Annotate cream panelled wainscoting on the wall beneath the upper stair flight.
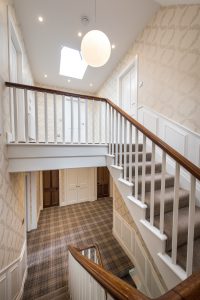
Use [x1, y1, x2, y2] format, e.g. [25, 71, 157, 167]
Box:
[113, 211, 166, 298]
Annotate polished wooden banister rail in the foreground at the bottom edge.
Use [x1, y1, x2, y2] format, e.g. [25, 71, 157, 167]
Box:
[68, 245, 200, 300]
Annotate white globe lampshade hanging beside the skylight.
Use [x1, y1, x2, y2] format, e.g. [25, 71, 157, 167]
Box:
[81, 30, 111, 67]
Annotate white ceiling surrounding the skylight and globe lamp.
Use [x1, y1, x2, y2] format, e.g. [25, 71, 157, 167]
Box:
[13, 0, 160, 93]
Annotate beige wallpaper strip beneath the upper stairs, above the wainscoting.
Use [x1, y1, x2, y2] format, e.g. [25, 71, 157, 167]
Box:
[113, 184, 165, 286]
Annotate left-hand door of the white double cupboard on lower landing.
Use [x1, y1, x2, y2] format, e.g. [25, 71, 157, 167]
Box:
[67, 169, 78, 204]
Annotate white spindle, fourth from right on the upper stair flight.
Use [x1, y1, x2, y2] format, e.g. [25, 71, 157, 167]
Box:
[150, 142, 155, 225]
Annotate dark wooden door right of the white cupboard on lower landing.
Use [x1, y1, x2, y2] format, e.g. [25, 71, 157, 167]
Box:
[97, 167, 110, 198]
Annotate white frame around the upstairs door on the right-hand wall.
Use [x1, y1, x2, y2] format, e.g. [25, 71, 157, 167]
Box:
[117, 55, 139, 119]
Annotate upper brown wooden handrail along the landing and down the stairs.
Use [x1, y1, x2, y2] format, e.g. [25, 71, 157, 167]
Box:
[5, 82, 200, 180]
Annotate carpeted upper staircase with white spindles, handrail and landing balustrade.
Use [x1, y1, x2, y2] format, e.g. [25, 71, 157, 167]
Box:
[6, 83, 200, 296]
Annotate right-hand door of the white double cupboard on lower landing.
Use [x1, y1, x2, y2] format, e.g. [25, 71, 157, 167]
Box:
[78, 168, 90, 202]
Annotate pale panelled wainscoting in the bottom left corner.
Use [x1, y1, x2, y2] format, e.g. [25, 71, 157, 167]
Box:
[0, 240, 27, 300]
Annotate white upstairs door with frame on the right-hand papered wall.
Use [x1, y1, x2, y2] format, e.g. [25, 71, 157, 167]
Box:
[118, 56, 138, 119]
